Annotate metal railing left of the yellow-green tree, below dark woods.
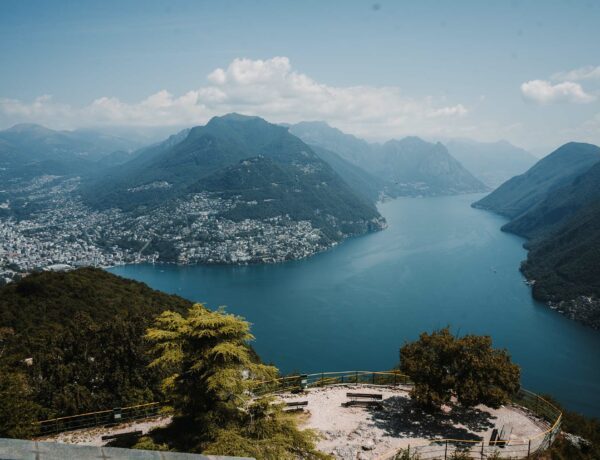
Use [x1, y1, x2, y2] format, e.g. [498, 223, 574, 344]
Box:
[34, 402, 163, 436]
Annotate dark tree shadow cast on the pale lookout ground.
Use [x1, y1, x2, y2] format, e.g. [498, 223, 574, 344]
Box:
[370, 396, 495, 441]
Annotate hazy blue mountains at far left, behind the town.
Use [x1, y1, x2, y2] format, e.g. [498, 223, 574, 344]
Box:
[0, 124, 139, 180]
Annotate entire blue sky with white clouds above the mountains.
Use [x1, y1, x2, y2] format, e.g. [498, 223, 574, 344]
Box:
[0, 0, 600, 153]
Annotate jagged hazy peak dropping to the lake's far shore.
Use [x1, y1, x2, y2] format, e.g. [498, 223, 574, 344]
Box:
[373, 137, 487, 195]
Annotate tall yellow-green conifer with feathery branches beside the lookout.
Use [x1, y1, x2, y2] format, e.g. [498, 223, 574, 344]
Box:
[144, 304, 321, 459]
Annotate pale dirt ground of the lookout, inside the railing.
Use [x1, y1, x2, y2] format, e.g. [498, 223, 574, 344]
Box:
[279, 385, 546, 460]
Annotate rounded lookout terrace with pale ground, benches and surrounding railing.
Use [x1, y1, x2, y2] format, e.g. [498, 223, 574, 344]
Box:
[264, 372, 561, 460]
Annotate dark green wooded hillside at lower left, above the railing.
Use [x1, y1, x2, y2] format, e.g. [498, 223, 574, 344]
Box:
[0, 268, 191, 418]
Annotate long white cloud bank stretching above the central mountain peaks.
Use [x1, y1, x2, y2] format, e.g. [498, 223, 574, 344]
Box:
[0, 57, 469, 137]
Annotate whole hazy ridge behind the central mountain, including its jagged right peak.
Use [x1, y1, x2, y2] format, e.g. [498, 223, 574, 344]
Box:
[289, 122, 487, 196]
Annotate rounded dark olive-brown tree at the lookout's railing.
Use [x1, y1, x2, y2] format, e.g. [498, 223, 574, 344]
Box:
[400, 328, 520, 409]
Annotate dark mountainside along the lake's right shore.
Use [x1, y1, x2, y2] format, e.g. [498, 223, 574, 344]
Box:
[473, 142, 600, 328]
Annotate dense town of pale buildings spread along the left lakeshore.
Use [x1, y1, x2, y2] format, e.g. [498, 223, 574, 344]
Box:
[0, 178, 335, 284]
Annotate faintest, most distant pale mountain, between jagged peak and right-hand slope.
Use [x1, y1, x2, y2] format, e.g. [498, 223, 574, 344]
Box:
[445, 139, 538, 188]
